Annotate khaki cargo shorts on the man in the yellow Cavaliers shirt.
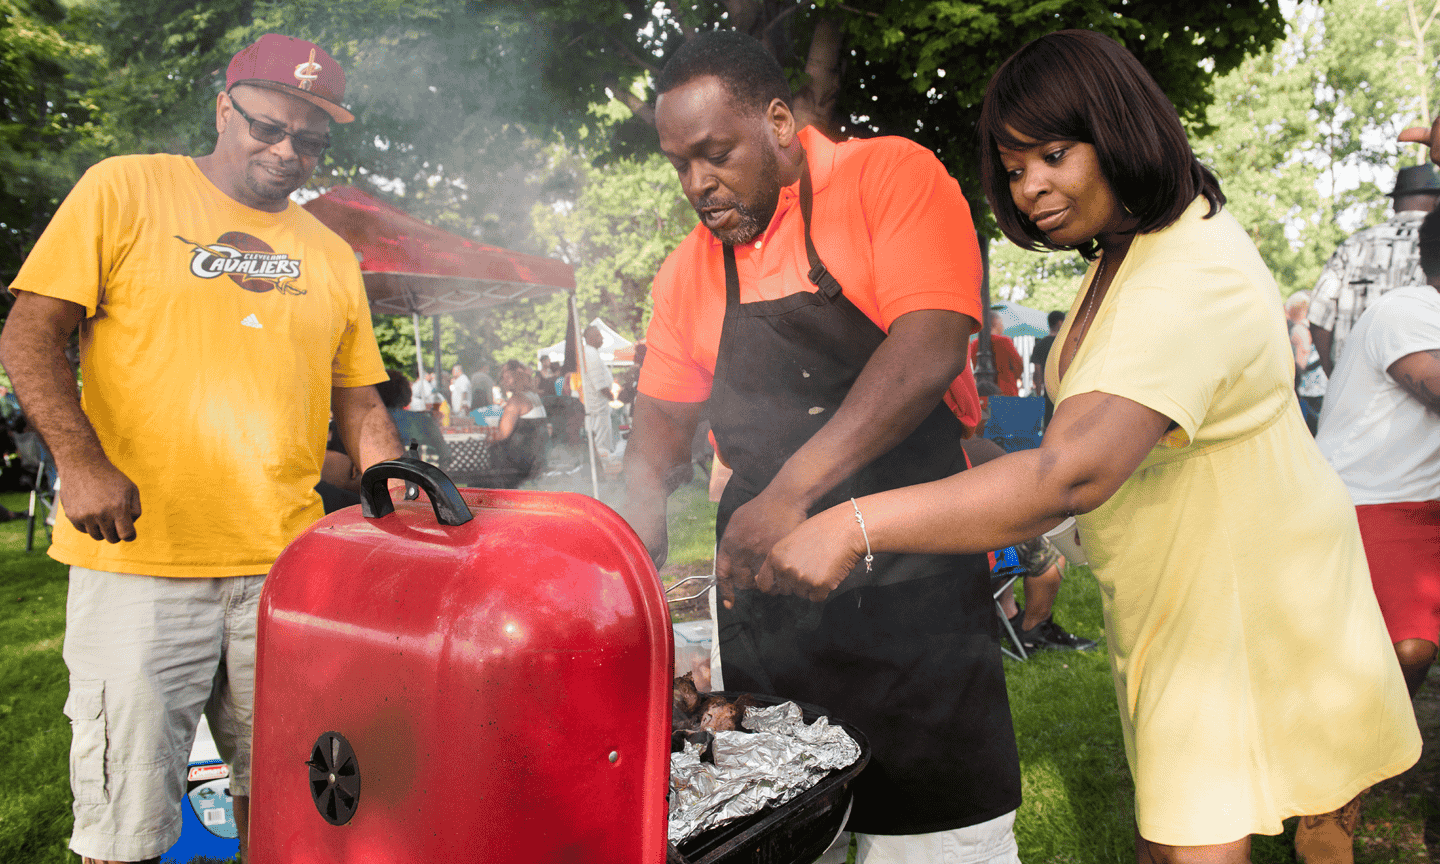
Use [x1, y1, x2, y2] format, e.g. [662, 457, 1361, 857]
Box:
[65, 567, 265, 861]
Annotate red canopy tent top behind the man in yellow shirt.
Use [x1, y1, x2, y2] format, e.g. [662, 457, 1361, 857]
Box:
[304, 186, 575, 315]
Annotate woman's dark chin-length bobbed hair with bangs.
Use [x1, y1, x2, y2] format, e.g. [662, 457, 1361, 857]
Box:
[979, 30, 1225, 258]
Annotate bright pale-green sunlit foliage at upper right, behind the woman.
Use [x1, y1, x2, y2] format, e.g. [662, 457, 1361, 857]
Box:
[1195, 0, 1433, 294]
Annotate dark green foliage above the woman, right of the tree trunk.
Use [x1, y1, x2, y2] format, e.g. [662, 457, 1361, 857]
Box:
[816, 0, 1283, 220]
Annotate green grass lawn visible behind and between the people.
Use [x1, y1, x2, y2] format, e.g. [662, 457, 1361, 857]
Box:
[0, 477, 1440, 864]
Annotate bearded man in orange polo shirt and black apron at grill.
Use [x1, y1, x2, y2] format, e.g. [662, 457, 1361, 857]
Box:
[625, 32, 1020, 863]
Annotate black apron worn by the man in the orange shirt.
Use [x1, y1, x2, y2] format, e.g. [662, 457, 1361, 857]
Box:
[708, 166, 1020, 834]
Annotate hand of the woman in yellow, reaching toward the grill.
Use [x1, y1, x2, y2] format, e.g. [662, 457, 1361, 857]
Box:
[755, 501, 865, 603]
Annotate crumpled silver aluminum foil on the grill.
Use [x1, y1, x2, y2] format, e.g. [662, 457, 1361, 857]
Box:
[670, 703, 860, 844]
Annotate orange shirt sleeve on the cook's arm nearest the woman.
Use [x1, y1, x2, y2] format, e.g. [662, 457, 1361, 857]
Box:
[864, 148, 982, 331]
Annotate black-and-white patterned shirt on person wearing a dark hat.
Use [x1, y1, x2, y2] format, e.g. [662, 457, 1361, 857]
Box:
[1309, 210, 1426, 363]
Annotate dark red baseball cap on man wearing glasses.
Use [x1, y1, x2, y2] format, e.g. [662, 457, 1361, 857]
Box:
[225, 33, 356, 122]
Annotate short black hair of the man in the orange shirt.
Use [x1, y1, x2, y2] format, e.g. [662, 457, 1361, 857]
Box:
[655, 30, 791, 111]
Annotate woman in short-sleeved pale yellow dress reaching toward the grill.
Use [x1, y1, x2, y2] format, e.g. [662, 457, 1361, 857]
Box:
[757, 30, 1420, 864]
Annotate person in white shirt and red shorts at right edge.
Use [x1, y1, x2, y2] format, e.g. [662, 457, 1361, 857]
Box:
[1315, 212, 1440, 697]
